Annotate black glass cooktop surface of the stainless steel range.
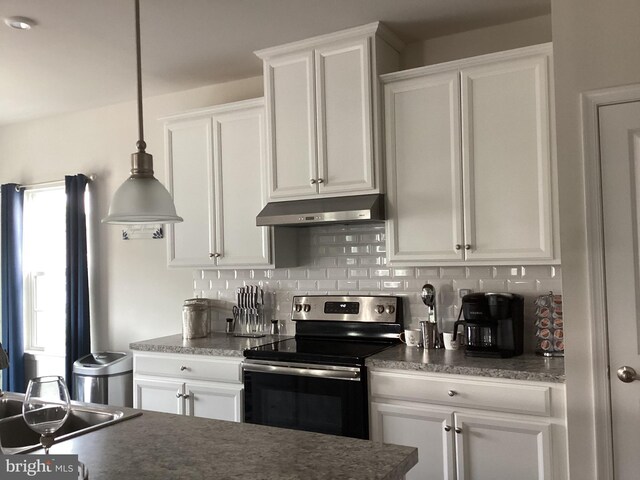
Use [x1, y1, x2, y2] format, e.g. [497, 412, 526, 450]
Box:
[244, 338, 397, 365]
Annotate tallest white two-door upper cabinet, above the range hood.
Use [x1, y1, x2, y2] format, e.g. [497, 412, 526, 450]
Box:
[256, 23, 402, 201]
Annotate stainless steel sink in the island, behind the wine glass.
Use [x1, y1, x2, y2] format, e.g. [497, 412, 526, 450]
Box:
[0, 394, 142, 454]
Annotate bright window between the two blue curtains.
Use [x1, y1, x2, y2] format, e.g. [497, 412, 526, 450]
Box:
[22, 184, 66, 355]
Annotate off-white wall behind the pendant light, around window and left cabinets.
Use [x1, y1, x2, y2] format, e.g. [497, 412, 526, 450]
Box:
[0, 77, 262, 350]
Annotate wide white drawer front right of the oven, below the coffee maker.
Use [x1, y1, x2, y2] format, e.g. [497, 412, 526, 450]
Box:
[371, 371, 551, 416]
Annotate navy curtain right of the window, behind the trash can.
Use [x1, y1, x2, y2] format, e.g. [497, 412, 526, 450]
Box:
[64, 174, 91, 391]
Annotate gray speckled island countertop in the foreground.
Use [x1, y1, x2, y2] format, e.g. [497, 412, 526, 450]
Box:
[48, 411, 418, 480]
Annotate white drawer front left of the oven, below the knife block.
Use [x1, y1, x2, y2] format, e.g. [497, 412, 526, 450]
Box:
[133, 354, 242, 383]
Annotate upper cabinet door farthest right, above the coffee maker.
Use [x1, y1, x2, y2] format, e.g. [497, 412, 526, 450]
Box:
[461, 55, 553, 260]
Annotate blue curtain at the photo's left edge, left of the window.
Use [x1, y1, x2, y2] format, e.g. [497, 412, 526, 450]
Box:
[0, 183, 25, 392]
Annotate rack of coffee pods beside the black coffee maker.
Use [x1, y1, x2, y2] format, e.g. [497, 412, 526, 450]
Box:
[534, 292, 564, 357]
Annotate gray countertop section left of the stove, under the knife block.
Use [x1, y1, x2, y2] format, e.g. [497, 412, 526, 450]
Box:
[129, 332, 291, 357]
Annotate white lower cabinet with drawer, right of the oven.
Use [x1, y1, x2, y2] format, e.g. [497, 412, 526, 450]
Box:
[371, 370, 568, 480]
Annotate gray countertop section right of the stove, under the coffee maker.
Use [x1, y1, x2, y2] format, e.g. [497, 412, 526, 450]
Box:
[366, 345, 564, 383]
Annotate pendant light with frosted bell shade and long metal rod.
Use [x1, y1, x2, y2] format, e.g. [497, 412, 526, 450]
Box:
[102, 0, 182, 225]
